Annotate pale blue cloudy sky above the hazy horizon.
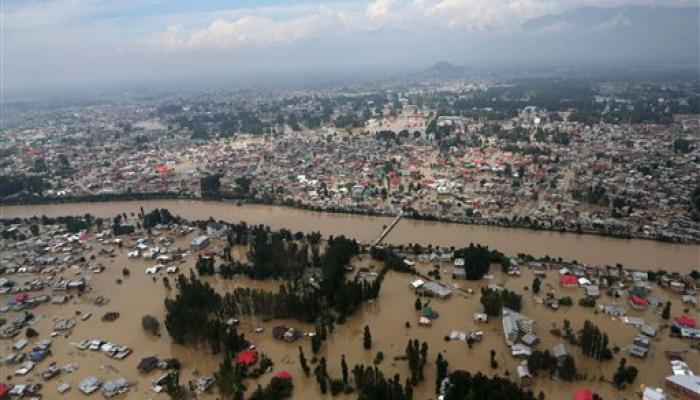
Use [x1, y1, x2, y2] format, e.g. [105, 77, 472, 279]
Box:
[0, 0, 697, 92]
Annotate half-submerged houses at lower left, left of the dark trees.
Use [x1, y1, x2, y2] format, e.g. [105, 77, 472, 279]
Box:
[0, 220, 189, 398]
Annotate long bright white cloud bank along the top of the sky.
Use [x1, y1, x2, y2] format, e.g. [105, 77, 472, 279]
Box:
[148, 0, 556, 50]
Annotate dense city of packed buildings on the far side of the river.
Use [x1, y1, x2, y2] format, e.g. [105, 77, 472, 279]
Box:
[0, 79, 700, 243]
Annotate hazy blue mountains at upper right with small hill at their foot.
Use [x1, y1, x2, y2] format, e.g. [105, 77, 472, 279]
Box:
[415, 6, 700, 79]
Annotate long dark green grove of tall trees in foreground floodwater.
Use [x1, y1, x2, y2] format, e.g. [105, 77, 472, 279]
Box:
[165, 237, 381, 352]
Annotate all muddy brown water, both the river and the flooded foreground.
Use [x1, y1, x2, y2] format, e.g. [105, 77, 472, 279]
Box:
[0, 201, 700, 400]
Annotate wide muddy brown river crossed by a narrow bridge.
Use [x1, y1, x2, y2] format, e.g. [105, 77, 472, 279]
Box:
[0, 200, 700, 272]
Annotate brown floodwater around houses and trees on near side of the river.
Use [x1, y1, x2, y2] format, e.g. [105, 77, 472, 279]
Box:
[0, 225, 700, 400]
